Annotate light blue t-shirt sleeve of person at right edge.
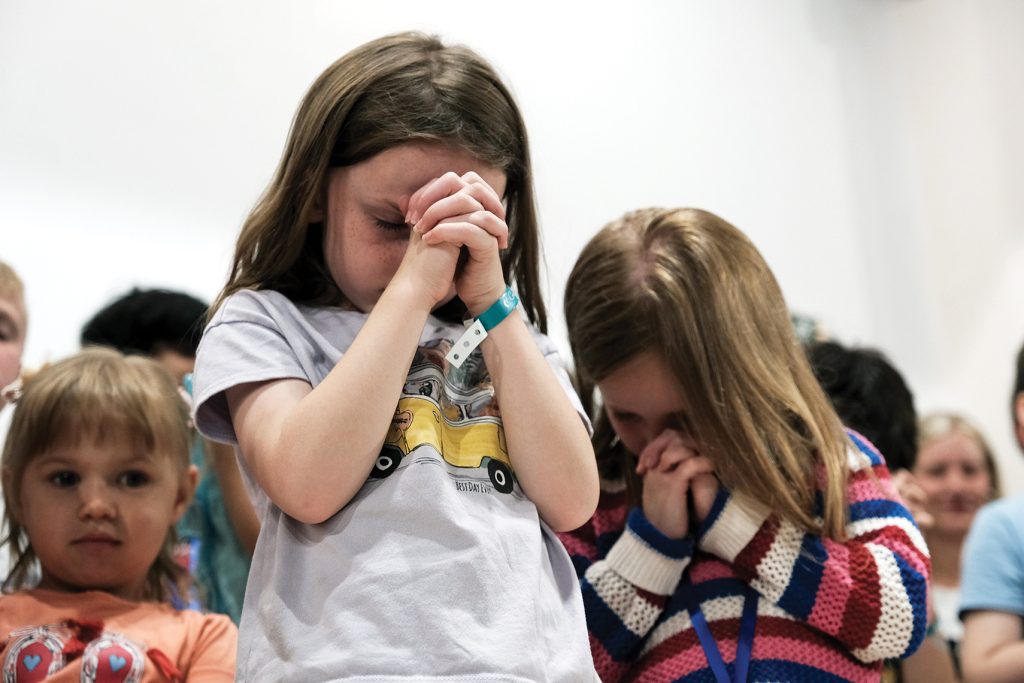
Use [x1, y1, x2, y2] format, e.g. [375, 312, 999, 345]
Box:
[961, 502, 1024, 616]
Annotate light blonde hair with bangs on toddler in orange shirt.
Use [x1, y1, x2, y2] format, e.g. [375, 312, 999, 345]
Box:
[2, 347, 190, 600]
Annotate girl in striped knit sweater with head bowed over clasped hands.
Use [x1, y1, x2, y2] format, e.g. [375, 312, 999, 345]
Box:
[562, 209, 929, 683]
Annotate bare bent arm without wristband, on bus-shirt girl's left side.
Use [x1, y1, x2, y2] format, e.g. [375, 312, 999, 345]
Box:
[235, 279, 429, 523]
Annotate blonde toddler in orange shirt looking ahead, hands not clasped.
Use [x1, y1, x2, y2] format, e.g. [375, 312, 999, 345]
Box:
[0, 348, 238, 681]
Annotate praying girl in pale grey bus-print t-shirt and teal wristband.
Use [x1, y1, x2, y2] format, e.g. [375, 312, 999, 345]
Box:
[195, 34, 598, 682]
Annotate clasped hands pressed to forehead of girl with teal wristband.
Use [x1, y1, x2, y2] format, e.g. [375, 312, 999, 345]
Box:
[399, 171, 509, 315]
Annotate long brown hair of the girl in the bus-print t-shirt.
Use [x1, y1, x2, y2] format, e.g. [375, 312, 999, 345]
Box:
[213, 33, 547, 331]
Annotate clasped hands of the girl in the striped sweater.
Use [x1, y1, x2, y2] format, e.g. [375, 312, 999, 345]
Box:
[636, 429, 719, 539]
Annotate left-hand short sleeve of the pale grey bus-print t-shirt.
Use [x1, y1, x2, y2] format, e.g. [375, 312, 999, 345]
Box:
[193, 292, 309, 444]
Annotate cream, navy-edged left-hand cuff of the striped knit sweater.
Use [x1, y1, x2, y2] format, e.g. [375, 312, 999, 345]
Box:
[604, 508, 693, 595]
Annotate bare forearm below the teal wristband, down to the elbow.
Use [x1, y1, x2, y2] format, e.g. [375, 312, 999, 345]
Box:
[482, 315, 599, 530]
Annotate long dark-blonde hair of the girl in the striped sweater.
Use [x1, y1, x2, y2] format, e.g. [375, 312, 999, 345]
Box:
[565, 209, 849, 539]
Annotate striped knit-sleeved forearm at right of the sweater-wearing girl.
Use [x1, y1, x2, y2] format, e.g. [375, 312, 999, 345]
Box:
[698, 483, 929, 661]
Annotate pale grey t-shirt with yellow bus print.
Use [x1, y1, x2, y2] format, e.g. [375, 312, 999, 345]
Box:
[195, 291, 597, 683]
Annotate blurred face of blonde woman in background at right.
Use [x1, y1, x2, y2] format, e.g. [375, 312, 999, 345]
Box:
[913, 433, 992, 536]
